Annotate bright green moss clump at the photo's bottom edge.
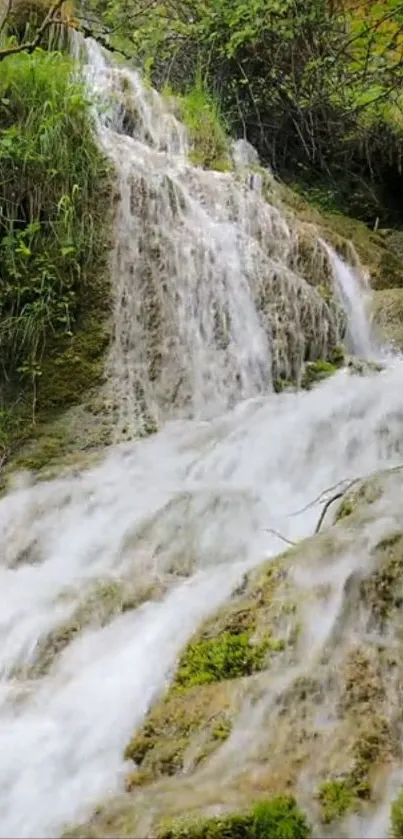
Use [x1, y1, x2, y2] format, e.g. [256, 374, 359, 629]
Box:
[158, 796, 311, 839]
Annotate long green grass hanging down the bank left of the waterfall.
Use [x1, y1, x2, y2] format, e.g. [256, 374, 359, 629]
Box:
[0, 50, 109, 420]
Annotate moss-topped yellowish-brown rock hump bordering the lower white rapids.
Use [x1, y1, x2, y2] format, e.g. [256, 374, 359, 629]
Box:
[125, 561, 298, 782]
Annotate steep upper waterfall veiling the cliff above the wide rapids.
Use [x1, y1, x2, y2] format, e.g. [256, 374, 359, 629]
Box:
[77, 40, 374, 440]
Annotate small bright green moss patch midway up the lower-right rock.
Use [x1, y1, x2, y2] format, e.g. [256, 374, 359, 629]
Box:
[175, 632, 279, 687]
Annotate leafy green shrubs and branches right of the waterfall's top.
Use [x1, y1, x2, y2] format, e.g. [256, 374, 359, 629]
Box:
[93, 0, 403, 223]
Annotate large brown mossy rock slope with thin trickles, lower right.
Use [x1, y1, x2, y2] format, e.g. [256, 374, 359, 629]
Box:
[66, 468, 403, 839]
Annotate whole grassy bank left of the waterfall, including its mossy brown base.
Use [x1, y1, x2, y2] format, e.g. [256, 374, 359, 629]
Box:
[0, 29, 111, 470]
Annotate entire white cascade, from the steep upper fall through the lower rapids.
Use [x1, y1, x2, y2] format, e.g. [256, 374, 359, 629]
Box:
[0, 31, 403, 837]
